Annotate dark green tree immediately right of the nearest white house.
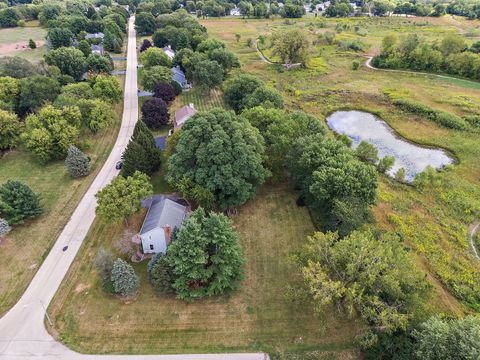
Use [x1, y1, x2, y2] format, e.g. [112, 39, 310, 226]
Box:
[167, 208, 244, 300]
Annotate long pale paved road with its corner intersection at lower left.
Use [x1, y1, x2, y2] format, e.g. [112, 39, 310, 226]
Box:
[0, 18, 267, 360]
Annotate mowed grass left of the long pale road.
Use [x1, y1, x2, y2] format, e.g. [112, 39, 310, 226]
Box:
[0, 78, 123, 315]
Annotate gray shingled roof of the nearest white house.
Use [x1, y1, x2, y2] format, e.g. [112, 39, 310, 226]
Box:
[140, 197, 187, 235]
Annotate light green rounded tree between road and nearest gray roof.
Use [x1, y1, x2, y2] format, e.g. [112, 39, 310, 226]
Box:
[95, 171, 153, 223]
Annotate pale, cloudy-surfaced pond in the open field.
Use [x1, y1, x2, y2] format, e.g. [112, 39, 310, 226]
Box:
[327, 111, 454, 181]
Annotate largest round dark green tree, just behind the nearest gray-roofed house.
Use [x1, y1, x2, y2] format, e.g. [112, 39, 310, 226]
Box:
[168, 108, 269, 210]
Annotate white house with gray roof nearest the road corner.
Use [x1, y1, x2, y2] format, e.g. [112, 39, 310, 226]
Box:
[139, 196, 188, 254]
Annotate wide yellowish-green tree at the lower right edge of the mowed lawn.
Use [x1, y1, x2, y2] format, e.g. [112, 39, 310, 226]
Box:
[298, 231, 429, 332]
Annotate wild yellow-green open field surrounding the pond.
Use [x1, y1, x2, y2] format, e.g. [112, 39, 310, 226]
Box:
[202, 17, 480, 312]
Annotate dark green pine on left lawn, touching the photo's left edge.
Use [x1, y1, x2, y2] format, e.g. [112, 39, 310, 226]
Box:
[0, 180, 43, 225]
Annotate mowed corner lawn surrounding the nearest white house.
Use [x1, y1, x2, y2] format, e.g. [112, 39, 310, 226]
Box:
[49, 185, 360, 358]
